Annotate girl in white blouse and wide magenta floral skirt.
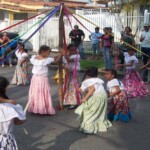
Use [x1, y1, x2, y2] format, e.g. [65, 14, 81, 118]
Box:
[119, 48, 149, 98]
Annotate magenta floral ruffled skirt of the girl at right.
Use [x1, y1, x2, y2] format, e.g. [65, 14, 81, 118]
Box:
[122, 69, 150, 98]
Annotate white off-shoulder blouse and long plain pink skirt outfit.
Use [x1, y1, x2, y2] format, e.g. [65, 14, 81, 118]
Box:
[28, 55, 55, 115]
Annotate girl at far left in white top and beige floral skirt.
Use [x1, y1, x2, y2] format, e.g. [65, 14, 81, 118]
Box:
[12, 42, 30, 85]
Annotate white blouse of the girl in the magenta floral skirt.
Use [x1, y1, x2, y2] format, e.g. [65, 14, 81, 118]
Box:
[124, 52, 138, 69]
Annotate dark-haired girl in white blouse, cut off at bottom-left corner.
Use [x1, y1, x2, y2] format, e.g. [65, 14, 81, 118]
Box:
[0, 77, 26, 150]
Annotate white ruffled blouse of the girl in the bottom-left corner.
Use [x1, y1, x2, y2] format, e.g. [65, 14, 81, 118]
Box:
[0, 103, 26, 134]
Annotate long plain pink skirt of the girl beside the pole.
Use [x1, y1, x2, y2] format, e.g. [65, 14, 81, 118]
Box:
[28, 75, 55, 115]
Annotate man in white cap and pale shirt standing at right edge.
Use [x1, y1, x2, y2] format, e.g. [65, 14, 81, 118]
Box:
[140, 24, 150, 65]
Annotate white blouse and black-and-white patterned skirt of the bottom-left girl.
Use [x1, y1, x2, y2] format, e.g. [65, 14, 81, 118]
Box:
[0, 103, 26, 150]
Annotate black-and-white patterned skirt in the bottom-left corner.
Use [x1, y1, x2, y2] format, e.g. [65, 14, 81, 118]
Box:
[0, 134, 18, 150]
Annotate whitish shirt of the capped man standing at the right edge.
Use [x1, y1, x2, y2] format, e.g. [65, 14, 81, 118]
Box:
[141, 30, 150, 48]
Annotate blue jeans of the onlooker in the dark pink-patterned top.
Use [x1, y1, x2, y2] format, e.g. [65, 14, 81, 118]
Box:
[102, 47, 112, 69]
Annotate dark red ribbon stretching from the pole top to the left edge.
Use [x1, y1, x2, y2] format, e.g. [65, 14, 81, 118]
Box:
[0, 10, 50, 32]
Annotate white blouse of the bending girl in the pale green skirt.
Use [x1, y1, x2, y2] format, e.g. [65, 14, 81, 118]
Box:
[81, 78, 105, 94]
